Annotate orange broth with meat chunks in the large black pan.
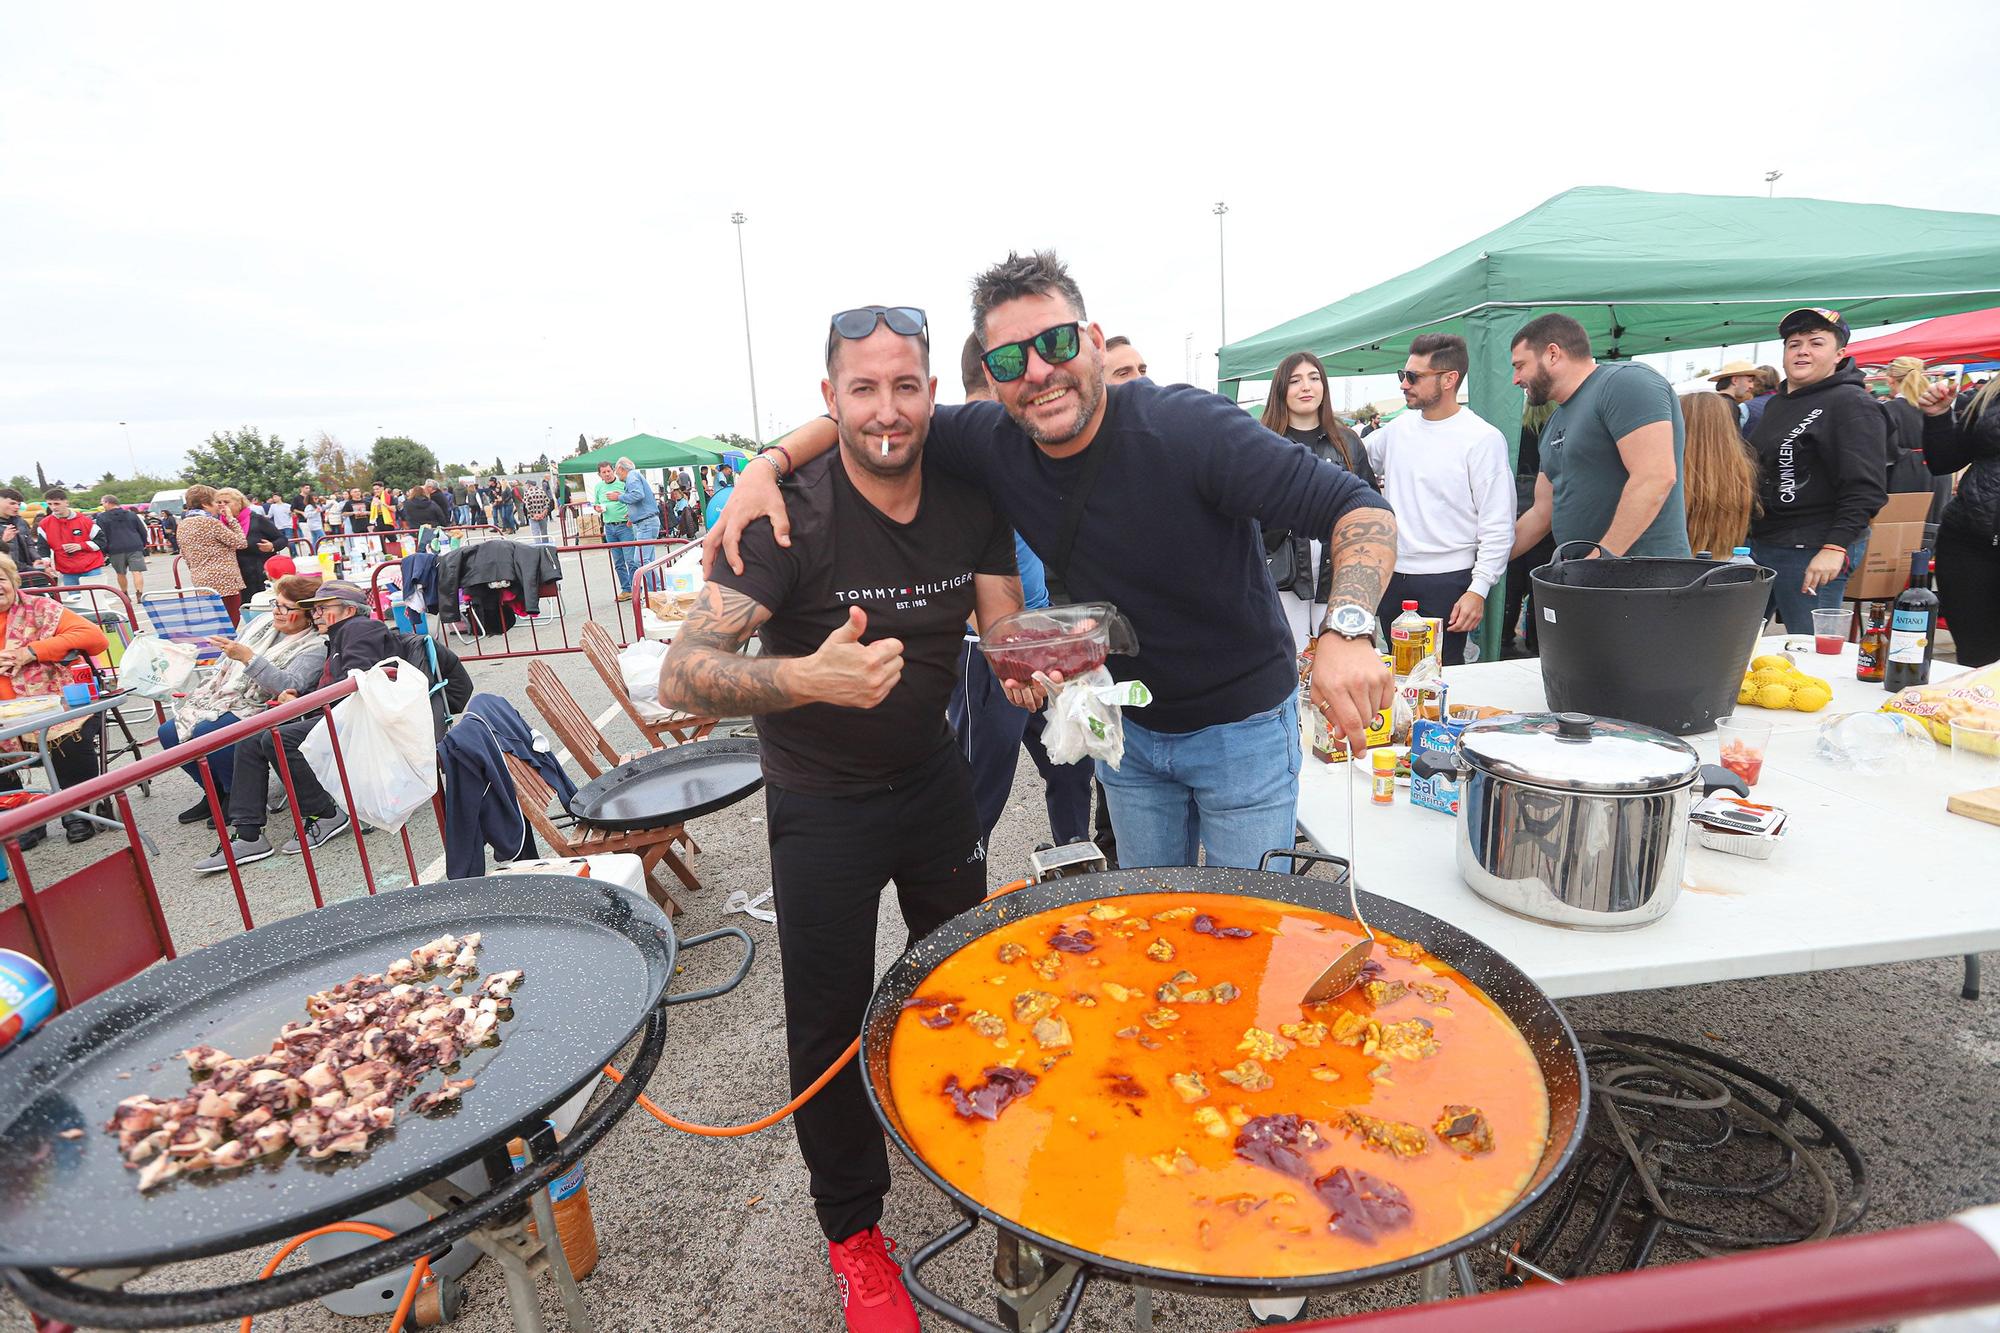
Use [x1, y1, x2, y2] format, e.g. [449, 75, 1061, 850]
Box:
[888, 893, 1548, 1277]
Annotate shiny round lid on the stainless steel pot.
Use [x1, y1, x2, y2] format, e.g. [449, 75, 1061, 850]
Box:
[1458, 713, 1700, 793]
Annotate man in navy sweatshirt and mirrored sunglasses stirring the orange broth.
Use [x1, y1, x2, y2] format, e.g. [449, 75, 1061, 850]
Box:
[708, 252, 1396, 867]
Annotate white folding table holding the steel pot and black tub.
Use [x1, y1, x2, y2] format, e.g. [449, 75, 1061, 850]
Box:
[1298, 636, 2000, 997]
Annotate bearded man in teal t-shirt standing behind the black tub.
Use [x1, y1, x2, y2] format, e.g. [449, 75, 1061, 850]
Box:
[1512, 314, 1690, 556]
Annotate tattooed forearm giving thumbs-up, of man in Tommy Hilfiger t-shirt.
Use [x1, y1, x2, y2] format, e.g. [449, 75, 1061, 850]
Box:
[660, 582, 902, 717]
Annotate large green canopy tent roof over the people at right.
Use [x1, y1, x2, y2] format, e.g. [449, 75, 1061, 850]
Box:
[1220, 186, 2000, 654]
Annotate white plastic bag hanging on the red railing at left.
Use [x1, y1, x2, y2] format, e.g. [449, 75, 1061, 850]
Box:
[300, 662, 438, 833]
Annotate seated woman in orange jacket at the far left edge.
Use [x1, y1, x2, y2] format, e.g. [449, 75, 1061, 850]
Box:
[0, 556, 110, 851]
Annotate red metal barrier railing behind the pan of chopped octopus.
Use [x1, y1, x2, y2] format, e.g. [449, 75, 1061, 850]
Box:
[0, 679, 444, 1007]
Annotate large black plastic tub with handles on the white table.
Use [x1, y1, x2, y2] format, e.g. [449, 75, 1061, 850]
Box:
[1528, 542, 1776, 737]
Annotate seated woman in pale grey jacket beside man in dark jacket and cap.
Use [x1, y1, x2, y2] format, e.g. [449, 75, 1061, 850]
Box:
[160, 574, 326, 825]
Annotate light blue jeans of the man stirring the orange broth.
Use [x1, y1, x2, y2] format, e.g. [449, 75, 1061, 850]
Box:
[1098, 693, 1300, 869]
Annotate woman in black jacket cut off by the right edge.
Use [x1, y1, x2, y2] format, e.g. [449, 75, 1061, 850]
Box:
[1918, 376, 2000, 667]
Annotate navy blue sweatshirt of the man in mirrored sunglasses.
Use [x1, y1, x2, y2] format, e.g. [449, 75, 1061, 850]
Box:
[924, 380, 1388, 733]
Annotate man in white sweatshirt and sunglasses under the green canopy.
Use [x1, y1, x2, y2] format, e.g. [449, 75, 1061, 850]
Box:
[1366, 334, 1514, 667]
